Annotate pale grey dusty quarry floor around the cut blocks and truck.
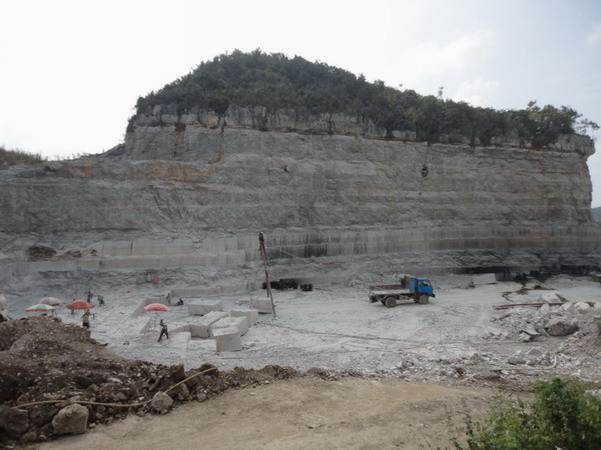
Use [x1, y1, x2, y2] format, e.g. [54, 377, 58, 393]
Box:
[9, 275, 601, 383]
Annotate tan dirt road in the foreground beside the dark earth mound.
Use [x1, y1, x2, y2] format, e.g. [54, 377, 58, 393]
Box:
[40, 377, 493, 450]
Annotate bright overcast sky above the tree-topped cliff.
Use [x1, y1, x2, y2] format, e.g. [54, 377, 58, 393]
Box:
[0, 0, 601, 206]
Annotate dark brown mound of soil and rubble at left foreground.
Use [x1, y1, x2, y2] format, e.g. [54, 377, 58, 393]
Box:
[0, 316, 300, 448]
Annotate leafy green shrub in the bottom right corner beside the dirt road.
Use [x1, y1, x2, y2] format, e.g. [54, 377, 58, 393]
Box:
[452, 378, 601, 450]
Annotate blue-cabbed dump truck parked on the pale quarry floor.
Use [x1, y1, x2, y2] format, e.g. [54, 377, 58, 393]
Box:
[369, 276, 436, 308]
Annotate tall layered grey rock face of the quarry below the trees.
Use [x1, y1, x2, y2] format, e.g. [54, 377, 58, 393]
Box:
[0, 108, 601, 282]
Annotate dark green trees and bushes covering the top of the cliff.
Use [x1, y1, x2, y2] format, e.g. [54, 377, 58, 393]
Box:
[130, 50, 598, 147]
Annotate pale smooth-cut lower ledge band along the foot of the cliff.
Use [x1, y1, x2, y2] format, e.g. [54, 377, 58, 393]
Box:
[3, 226, 601, 277]
